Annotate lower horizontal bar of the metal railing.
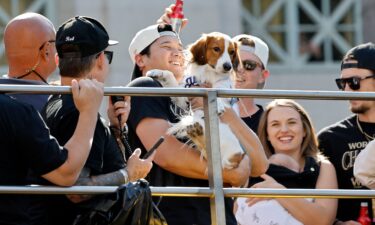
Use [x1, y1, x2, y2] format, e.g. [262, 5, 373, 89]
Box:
[0, 185, 375, 199]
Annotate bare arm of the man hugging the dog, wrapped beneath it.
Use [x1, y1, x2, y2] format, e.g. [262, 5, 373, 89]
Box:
[136, 118, 250, 186]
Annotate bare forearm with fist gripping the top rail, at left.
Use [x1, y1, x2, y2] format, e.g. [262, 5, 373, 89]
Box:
[42, 80, 103, 186]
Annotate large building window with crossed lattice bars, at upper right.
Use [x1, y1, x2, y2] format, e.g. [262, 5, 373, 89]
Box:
[241, 0, 362, 68]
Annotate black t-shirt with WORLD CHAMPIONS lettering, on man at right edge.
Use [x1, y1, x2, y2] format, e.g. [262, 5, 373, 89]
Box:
[318, 116, 375, 221]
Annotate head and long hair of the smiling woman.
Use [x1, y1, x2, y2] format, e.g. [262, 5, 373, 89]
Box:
[258, 99, 320, 163]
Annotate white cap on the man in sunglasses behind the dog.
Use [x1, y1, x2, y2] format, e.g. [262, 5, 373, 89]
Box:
[232, 34, 269, 68]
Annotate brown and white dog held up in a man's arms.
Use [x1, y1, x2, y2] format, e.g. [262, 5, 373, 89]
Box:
[147, 32, 244, 169]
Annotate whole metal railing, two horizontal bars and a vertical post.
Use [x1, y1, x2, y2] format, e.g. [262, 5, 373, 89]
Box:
[0, 85, 375, 225]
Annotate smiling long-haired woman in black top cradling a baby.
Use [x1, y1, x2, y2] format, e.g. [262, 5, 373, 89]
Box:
[237, 99, 337, 225]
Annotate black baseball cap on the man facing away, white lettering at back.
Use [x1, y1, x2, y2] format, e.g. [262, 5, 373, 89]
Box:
[56, 16, 118, 58]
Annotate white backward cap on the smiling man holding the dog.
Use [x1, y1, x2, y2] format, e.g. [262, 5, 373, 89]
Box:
[129, 24, 178, 63]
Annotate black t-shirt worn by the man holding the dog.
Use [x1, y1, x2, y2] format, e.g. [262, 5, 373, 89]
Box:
[128, 77, 237, 225]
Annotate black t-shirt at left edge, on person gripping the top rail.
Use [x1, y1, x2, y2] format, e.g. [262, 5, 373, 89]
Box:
[0, 94, 68, 225]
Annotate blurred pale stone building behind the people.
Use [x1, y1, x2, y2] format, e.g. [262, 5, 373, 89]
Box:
[0, 0, 375, 128]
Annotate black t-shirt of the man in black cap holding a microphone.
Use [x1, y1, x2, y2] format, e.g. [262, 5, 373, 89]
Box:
[42, 95, 125, 224]
